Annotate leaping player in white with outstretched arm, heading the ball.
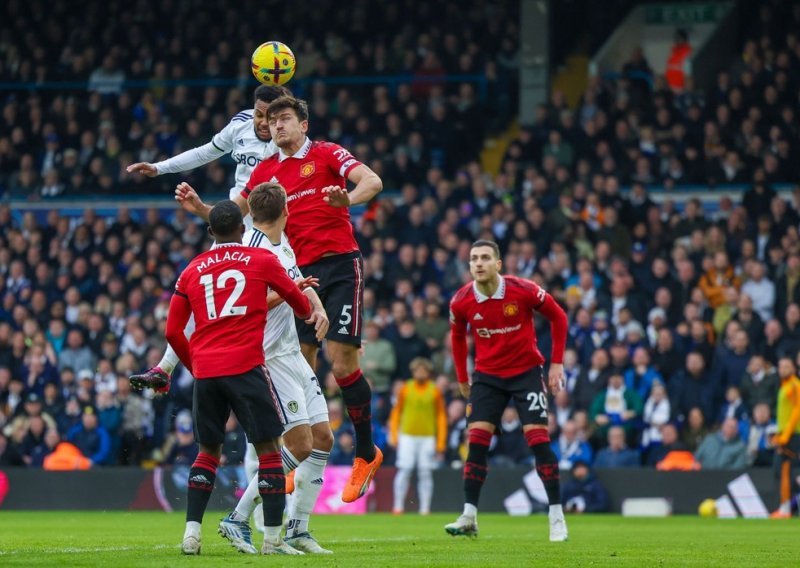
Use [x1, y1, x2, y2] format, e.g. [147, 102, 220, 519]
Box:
[127, 85, 289, 392]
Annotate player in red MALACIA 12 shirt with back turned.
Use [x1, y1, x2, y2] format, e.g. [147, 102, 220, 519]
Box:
[165, 201, 321, 554]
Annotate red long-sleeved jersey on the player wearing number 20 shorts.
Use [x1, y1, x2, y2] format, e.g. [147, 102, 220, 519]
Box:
[450, 276, 567, 383]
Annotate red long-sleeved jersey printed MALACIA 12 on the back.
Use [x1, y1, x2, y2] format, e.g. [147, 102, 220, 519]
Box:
[167, 243, 311, 379]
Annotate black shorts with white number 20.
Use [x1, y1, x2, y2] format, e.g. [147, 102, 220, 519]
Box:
[467, 367, 547, 426]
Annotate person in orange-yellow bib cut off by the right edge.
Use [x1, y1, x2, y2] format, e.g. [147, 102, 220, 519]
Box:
[772, 357, 800, 518]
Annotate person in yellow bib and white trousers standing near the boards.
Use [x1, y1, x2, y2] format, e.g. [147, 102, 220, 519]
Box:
[389, 357, 447, 515]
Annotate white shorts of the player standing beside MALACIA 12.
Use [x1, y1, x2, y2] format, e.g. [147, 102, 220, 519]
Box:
[267, 352, 328, 432]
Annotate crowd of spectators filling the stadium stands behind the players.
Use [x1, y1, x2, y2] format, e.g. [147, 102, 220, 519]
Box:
[0, 1, 800, 469]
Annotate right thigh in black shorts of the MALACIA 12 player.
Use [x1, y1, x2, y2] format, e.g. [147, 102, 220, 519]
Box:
[224, 367, 283, 445]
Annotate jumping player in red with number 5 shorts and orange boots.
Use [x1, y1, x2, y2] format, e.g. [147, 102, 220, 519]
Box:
[176, 96, 383, 502]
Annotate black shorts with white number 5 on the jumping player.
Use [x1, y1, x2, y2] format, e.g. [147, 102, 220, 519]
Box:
[295, 251, 364, 346]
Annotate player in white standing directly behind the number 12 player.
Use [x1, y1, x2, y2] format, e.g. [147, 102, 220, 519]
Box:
[219, 183, 333, 554]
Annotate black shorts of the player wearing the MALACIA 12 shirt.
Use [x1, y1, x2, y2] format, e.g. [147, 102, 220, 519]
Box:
[192, 367, 283, 446]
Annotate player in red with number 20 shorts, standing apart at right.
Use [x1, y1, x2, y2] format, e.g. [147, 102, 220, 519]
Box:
[445, 241, 567, 542]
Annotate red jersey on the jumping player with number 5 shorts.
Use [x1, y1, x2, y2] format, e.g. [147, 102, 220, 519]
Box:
[242, 138, 361, 267]
